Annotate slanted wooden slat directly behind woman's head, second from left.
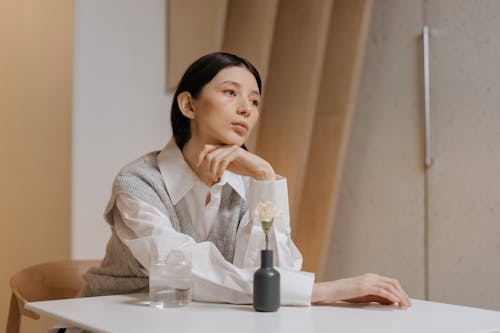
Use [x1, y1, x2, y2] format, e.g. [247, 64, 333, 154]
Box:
[222, 0, 278, 151]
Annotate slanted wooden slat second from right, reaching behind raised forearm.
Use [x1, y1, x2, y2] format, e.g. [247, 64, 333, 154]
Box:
[256, 0, 333, 228]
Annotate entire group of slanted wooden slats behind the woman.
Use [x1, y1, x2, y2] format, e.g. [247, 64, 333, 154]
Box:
[168, 0, 372, 278]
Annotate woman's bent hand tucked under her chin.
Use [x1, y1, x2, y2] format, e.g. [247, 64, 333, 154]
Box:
[196, 145, 276, 181]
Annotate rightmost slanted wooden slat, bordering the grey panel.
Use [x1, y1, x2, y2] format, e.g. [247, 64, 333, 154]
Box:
[296, 0, 372, 273]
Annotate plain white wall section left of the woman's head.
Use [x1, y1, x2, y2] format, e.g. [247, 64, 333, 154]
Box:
[72, 0, 171, 258]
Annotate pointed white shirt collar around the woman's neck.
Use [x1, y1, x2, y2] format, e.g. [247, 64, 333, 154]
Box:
[157, 138, 245, 205]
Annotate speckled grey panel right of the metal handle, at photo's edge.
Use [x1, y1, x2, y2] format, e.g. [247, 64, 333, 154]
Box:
[425, 0, 500, 310]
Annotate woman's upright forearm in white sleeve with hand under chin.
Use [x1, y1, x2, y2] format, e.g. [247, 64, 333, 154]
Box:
[196, 145, 302, 271]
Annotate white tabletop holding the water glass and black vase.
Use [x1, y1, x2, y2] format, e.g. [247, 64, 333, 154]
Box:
[26, 294, 500, 333]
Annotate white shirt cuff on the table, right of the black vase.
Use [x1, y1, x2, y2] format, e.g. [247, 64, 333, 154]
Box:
[276, 267, 314, 306]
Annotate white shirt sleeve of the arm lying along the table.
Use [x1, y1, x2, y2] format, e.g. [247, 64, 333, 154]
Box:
[114, 193, 314, 305]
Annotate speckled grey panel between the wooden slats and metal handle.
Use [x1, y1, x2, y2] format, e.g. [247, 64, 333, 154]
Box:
[322, 0, 425, 298]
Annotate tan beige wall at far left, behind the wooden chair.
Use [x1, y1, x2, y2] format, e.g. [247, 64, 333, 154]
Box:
[0, 0, 73, 332]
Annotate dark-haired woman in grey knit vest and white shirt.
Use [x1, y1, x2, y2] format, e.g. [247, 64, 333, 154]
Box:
[83, 52, 411, 308]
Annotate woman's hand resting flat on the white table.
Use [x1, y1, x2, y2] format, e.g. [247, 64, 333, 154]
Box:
[311, 273, 411, 308]
